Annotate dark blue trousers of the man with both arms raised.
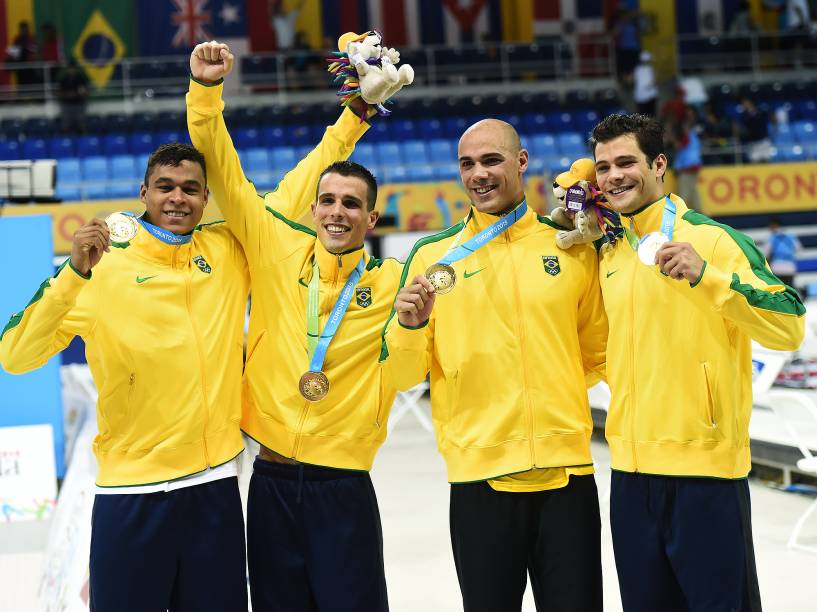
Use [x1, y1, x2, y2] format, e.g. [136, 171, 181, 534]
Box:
[247, 459, 389, 612]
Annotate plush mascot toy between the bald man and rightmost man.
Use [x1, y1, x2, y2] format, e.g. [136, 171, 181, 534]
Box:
[551, 157, 621, 249]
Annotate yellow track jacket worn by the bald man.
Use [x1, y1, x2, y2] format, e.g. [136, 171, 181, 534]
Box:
[386, 208, 607, 482]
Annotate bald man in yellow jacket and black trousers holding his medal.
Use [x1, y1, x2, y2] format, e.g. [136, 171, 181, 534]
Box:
[386, 119, 607, 612]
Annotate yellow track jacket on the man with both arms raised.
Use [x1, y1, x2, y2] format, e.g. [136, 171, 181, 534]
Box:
[187, 76, 402, 470]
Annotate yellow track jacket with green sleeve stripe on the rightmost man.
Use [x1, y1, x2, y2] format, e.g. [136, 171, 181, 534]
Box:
[599, 195, 805, 478]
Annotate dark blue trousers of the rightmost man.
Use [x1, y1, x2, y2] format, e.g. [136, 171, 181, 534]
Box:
[610, 471, 760, 612]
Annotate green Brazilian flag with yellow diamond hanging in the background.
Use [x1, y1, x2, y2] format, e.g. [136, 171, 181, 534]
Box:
[34, 0, 134, 89]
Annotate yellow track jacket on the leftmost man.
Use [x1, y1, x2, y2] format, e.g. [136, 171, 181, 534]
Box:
[0, 223, 249, 487]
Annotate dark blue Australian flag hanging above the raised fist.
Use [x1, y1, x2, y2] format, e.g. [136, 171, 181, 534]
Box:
[139, 0, 247, 56]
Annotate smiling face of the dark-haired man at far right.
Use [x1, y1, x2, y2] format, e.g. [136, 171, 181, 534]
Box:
[595, 134, 667, 213]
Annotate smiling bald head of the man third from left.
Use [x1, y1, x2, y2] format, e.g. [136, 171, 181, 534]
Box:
[457, 119, 528, 214]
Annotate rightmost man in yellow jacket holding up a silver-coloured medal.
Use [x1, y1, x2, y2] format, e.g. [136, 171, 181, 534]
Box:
[591, 115, 805, 612]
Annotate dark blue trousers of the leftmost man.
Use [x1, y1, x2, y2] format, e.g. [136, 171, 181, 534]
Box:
[90, 477, 247, 612]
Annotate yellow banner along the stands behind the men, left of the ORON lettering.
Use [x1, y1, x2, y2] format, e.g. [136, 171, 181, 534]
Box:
[3, 176, 552, 255]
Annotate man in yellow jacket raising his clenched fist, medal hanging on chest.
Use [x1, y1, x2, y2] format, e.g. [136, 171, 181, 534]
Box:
[187, 43, 402, 612]
